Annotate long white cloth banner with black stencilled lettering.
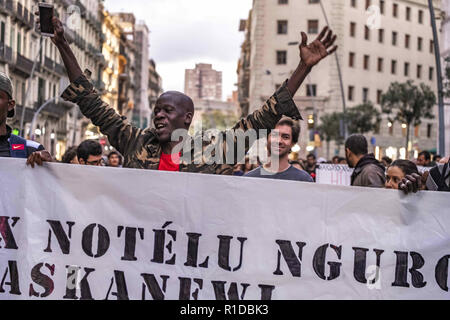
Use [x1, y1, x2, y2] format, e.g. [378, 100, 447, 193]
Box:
[0, 159, 450, 300]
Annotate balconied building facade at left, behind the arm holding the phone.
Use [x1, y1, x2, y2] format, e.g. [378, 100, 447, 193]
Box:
[0, 0, 104, 158]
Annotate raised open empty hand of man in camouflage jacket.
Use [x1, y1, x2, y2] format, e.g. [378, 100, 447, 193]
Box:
[300, 27, 338, 68]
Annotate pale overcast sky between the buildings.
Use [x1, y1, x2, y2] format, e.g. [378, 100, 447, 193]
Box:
[105, 0, 252, 99]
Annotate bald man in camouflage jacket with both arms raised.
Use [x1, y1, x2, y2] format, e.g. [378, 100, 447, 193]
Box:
[43, 17, 337, 175]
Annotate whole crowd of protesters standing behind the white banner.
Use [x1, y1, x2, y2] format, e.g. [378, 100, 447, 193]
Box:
[0, 17, 450, 193]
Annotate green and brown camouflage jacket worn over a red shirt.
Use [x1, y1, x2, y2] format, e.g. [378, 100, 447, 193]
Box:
[62, 76, 302, 175]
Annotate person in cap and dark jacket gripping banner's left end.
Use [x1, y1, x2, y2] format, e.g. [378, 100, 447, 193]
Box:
[0, 72, 52, 167]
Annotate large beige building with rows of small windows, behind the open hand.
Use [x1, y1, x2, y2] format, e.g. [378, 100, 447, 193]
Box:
[238, 0, 440, 159]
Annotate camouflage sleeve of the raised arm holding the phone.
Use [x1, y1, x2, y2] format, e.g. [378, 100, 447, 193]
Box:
[61, 75, 141, 156]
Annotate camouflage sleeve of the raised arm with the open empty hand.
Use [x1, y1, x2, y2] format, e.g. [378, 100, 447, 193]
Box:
[223, 80, 303, 163]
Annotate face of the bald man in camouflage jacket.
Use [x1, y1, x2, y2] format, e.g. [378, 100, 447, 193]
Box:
[153, 95, 190, 143]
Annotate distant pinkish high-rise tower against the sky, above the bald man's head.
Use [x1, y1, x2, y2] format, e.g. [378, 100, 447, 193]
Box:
[184, 63, 222, 100]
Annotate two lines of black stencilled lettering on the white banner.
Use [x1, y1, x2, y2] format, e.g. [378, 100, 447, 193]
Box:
[0, 216, 450, 300]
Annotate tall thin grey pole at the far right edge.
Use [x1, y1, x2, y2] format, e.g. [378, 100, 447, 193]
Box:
[428, 0, 446, 156]
